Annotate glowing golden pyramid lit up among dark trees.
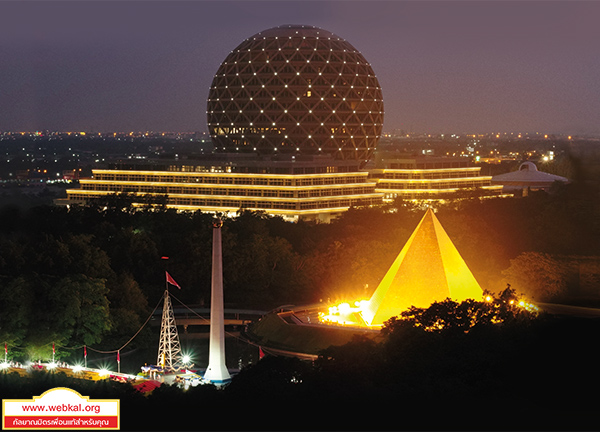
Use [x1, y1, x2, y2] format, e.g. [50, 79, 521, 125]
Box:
[362, 209, 483, 326]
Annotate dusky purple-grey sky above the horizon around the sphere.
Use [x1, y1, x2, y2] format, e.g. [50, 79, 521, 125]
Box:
[0, 0, 600, 134]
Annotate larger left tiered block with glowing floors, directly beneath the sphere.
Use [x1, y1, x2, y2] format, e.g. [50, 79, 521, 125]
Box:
[63, 156, 381, 222]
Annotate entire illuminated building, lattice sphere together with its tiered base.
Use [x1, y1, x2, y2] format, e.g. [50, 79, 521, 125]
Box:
[57, 26, 501, 222]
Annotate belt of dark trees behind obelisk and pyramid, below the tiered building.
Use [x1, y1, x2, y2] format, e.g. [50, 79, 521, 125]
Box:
[0, 183, 600, 359]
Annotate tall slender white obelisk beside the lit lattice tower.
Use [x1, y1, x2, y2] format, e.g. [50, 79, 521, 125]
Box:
[204, 219, 231, 384]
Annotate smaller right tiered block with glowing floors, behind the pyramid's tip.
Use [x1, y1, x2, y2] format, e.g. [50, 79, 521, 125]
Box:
[369, 156, 502, 201]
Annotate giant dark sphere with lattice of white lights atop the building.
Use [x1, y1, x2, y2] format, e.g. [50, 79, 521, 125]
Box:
[207, 26, 383, 161]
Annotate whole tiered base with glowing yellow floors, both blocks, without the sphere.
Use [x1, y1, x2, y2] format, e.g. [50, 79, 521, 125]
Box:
[57, 154, 502, 222]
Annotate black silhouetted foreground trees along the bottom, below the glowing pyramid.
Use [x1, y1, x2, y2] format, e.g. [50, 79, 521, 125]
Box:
[0, 300, 600, 430]
